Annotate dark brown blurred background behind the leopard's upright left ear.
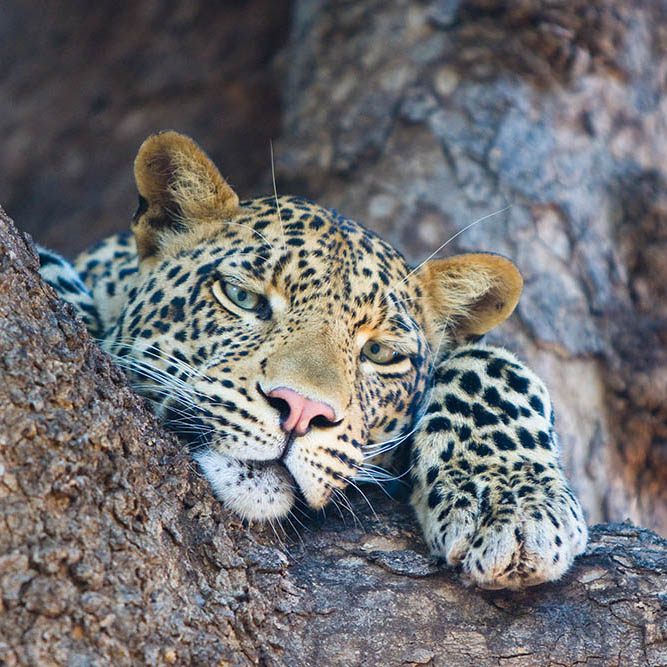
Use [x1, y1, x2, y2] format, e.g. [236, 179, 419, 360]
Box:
[0, 0, 289, 256]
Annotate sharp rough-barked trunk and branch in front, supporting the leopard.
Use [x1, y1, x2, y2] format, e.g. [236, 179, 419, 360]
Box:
[0, 209, 667, 666]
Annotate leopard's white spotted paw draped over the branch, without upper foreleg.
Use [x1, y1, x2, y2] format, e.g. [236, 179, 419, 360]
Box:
[413, 463, 587, 589]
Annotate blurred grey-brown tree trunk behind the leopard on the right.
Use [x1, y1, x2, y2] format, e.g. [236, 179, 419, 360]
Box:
[277, 0, 667, 534]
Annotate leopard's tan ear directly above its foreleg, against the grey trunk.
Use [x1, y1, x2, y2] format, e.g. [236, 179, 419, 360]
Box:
[417, 253, 523, 347]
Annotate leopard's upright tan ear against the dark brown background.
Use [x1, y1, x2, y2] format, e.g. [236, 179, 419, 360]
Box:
[132, 132, 239, 259]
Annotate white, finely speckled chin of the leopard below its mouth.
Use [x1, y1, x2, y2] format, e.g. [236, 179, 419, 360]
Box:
[194, 449, 294, 521]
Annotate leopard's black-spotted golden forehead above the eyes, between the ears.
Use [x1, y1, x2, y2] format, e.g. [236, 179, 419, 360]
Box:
[167, 197, 418, 306]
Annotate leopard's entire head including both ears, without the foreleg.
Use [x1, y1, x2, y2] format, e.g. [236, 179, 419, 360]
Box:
[79, 132, 521, 520]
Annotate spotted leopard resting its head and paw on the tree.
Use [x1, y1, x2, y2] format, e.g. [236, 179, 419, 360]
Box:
[39, 131, 587, 590]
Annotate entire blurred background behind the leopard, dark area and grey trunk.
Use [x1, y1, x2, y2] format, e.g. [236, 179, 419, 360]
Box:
[0, 0, 667, 534]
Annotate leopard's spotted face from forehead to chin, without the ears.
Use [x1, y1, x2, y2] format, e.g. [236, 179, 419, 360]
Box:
[109, 198, 431, 519]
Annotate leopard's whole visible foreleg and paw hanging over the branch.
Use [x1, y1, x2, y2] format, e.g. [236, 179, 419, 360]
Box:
[411, 345, 587, 589]
